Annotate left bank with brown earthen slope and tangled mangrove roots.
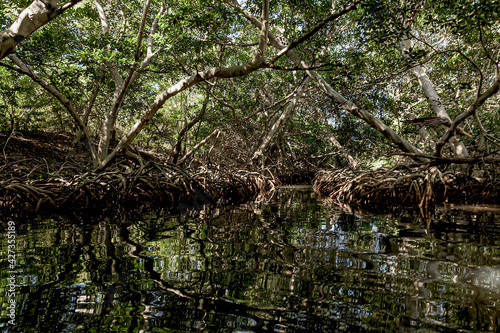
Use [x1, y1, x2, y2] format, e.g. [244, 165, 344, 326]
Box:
[0, 133, 275, 217]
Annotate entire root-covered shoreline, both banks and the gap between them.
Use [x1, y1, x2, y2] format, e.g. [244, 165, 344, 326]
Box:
[0, 132, 500, 217]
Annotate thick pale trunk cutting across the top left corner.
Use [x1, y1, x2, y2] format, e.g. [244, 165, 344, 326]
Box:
[0, 0, 81, 60]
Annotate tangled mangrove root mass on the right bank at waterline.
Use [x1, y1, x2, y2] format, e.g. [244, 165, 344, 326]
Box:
[314, 166, 500, 212]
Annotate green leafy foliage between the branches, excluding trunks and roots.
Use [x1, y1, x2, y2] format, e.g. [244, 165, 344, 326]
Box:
[0, 0, 500, 167]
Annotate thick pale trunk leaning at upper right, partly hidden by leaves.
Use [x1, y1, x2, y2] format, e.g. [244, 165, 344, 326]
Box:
[401, 38, 469, 157]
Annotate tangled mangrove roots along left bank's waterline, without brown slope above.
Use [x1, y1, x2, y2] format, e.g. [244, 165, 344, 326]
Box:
[0, 159, 272, 216]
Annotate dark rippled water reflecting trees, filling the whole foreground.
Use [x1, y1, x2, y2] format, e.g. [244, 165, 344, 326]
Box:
[0, 189, 500, 332]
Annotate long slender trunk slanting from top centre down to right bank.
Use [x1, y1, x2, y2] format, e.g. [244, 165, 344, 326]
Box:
[227, 0, 429, 162]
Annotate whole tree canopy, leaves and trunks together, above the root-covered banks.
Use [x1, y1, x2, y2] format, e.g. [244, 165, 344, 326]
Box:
[0, 0, 500, 170]
